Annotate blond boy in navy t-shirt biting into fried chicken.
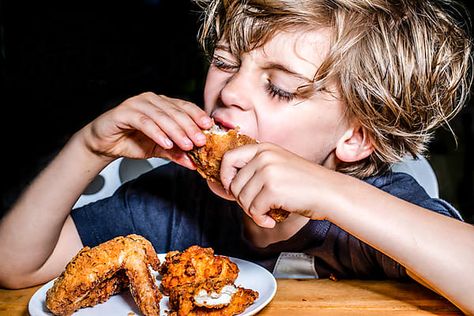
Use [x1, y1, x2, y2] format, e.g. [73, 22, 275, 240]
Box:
[0, 0, 473, 314]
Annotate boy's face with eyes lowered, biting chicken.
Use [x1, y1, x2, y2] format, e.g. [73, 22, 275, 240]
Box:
[204, 29, 348, 167]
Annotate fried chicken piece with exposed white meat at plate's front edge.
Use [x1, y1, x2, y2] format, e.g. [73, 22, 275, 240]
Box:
[169, 279, 258, 316]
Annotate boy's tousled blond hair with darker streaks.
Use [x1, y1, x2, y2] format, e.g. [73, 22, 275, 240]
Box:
[195, 0, 473, 178]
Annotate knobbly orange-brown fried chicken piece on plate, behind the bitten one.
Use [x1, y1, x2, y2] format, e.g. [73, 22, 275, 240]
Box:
[159, 245, 239, 294]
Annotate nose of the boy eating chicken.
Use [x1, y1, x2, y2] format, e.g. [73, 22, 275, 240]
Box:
[220, 71, 256, 111]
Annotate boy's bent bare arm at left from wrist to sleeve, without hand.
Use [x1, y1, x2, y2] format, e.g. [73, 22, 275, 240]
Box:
[0, 135, 110, 287]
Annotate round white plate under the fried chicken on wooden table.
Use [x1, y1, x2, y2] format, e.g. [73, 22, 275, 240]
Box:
[28, 254, 277, 316]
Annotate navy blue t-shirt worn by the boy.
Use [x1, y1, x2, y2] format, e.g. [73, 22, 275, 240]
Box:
[71, 163, 461, 279]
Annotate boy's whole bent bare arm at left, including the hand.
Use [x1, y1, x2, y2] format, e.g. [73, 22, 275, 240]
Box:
[0, 93, 212, 288]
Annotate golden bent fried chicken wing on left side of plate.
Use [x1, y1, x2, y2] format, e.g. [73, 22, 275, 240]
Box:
[46, 234, 162, 315]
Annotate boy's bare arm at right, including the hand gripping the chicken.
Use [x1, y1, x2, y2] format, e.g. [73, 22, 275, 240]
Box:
[221, 144, 474, 314]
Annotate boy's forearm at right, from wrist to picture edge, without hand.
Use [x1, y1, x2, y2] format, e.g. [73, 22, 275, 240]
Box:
[327, 174, 474, 313]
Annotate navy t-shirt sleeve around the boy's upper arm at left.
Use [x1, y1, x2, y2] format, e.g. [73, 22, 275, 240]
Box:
[71, 164, 179, 247]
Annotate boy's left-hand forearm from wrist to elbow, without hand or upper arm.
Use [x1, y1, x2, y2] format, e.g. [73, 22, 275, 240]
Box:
[0, 134, 112, 277]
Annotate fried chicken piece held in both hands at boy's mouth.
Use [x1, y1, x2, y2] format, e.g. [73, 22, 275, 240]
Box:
[188, 125, 289, 223]
